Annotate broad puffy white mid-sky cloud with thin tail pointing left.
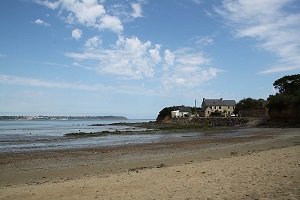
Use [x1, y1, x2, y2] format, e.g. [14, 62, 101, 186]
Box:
[66, 36, 160, 79]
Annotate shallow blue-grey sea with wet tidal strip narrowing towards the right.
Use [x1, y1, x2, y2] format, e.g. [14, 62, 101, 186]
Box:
[0, 120, 258, 153]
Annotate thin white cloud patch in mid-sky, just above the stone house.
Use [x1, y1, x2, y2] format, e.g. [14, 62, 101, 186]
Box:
[162, 48, 221, 90]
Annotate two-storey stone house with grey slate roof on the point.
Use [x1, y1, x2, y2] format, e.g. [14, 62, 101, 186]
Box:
[201, 98, 236, 117]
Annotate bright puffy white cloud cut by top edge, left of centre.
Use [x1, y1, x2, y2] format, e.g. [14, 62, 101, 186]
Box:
[37, 0, 123, 33]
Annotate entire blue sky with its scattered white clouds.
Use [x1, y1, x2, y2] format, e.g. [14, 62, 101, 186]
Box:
[0, 0, 300, 119]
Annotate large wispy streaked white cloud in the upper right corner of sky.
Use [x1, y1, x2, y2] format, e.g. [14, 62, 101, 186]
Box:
[216, 0, 300, 73]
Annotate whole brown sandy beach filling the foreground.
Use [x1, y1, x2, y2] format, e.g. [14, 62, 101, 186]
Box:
[0, 128, 300, 199]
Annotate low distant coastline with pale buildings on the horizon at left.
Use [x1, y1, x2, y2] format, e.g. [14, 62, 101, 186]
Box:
[0, 115, 128, 121]
